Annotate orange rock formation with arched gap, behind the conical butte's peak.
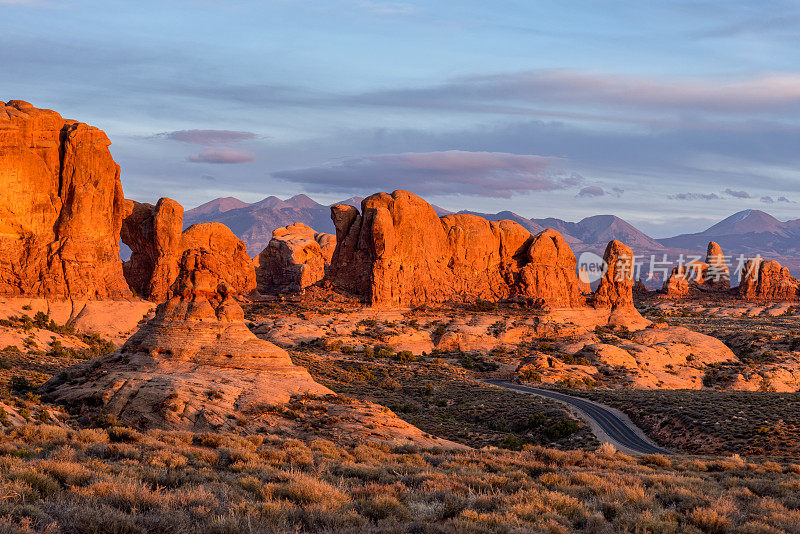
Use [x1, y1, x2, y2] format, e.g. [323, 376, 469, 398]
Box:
[121, 198, 256, 302]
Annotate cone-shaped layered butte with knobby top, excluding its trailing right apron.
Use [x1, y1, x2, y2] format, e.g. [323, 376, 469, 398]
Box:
[44, 258, 331, 431]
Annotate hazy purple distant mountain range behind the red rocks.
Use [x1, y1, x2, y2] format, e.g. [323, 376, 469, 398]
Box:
[189, 195, 800, 276]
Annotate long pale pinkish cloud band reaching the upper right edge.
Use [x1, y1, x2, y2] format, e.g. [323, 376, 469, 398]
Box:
[359, 70, 800, 117]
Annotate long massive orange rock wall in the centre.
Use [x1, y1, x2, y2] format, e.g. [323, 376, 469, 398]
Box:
[328, 191, 585, 306]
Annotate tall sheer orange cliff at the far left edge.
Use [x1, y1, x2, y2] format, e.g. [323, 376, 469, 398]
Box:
[0, 100, 131, 299]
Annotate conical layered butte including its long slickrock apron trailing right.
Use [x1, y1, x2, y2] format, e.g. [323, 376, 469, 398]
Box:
[42, 255, 463, 448]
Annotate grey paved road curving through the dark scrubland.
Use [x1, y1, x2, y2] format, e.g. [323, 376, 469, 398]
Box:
[485, 380, 672, 454]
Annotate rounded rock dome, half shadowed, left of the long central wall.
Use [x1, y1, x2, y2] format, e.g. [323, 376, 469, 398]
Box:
[256, 223, 336, 293]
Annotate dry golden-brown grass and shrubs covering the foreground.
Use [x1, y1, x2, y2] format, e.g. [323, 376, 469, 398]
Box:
[0, 424, 800, 533]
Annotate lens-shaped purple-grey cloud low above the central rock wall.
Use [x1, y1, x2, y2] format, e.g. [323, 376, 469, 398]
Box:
[271, 150, 583, 198]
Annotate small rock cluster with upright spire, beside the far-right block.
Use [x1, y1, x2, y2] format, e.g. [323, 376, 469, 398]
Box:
[663, 241, 731, 298]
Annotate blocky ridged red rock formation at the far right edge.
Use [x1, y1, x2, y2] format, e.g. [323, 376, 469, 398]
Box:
[739, 258, 800, 302]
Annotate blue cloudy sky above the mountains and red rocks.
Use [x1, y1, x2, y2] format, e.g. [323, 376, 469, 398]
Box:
[0, 0, 800, 238]
